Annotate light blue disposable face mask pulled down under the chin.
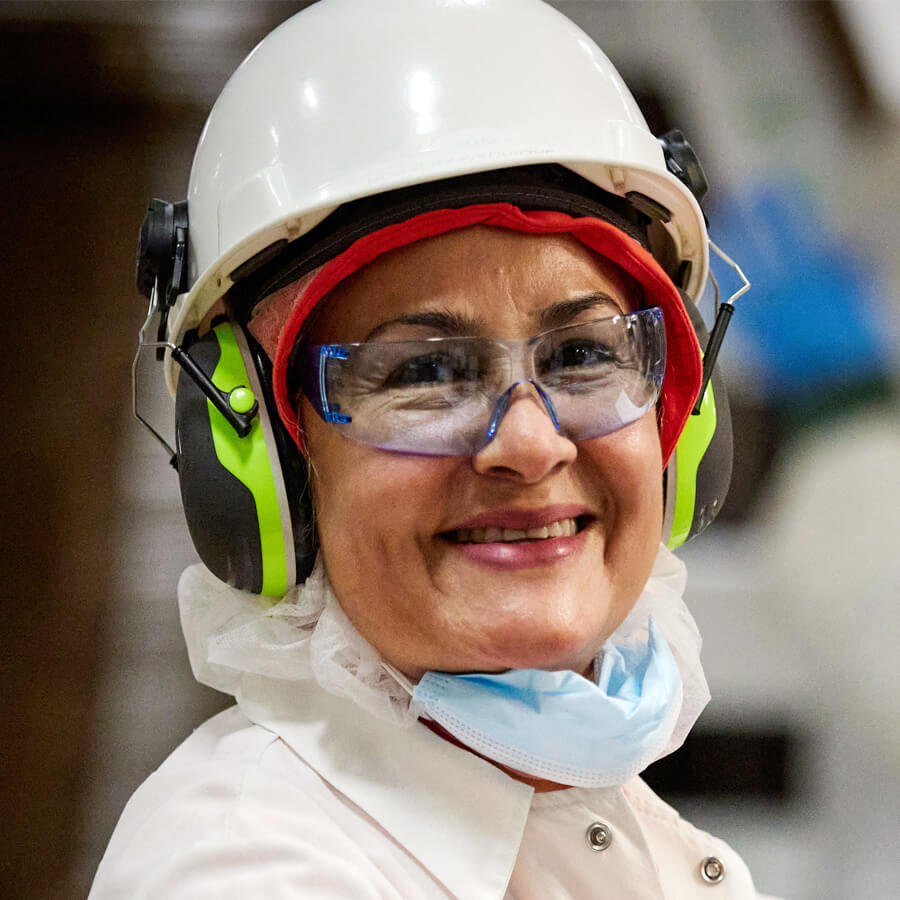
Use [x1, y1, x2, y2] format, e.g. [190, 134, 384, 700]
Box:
[412, 618, 682, 788]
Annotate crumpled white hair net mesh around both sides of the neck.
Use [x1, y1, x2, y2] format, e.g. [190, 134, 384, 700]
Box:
[178, 545, 709, 756]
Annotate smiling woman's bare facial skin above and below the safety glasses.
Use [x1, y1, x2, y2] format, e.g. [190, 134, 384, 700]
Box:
[301, 226, 662, 678]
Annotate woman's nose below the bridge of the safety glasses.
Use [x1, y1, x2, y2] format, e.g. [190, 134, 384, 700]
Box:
[472, 384, 578, 484]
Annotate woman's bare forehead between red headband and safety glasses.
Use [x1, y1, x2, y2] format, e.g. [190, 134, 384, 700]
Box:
[304, 226, 641, 343]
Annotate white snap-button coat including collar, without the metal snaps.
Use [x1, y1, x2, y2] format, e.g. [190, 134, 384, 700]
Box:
[89, 676, 757, 900]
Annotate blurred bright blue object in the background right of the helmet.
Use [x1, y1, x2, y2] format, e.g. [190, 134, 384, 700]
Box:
[710, 181, 890, 402]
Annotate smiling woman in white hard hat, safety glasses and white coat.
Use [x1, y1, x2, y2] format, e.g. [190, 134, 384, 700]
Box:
[91, 0, 768, 898]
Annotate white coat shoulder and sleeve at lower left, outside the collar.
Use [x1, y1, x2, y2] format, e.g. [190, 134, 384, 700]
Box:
[89, 709, 444, 900]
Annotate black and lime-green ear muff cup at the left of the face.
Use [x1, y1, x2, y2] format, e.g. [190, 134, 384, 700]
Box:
[175, 321, 316, 597]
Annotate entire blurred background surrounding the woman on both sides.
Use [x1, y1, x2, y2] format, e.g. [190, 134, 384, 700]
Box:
[0, 0, 900, 900]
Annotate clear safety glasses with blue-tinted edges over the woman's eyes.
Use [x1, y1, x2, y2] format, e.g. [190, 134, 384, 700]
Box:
[301, 307, 665, 455]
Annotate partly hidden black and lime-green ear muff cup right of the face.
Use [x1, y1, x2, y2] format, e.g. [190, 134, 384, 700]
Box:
[663, 294, 734, 550]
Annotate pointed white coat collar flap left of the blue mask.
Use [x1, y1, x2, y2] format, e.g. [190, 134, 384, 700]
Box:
[237, 673, 534, 900]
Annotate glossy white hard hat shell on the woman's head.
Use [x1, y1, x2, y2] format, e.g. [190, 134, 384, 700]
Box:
[168, 0, 708, 387]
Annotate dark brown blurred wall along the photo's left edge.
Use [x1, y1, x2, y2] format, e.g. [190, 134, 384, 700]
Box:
[0, 14, 202, 898]
